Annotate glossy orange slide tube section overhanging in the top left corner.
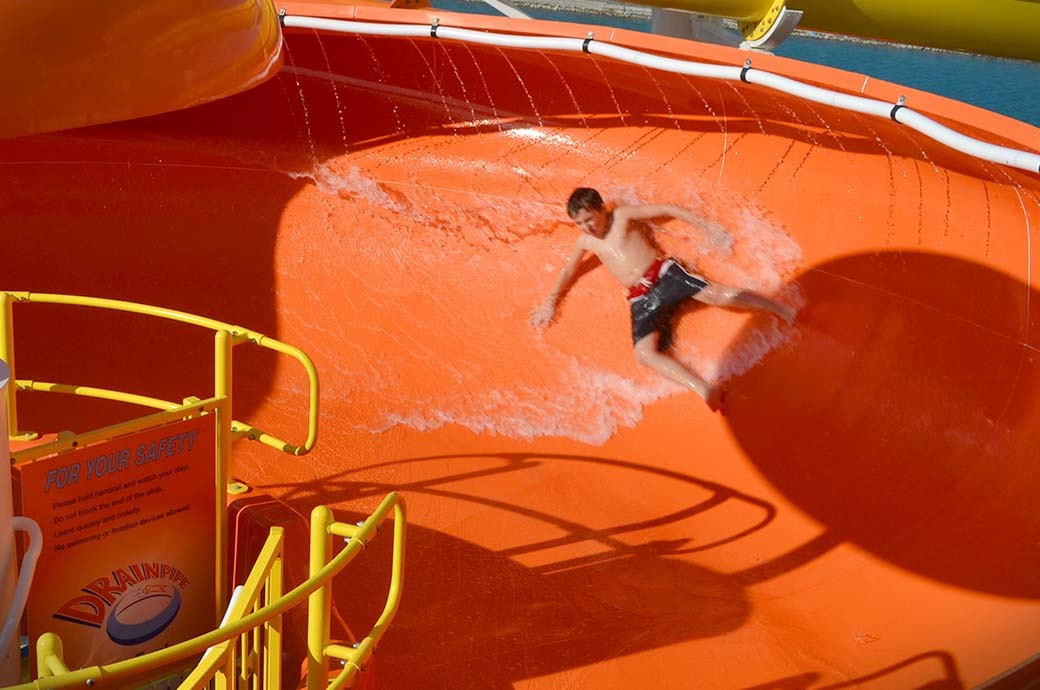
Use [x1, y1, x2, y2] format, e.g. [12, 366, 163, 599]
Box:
[0, 0, 282, 137]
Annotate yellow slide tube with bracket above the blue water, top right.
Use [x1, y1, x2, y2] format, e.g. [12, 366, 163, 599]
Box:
[631, 0, 1040, 60]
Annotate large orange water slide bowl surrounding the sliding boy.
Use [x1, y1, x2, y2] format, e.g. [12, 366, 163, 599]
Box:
[0, 5, 1040, 690]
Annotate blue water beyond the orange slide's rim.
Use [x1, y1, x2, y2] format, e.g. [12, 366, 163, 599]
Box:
[432, 0, 1040, 127]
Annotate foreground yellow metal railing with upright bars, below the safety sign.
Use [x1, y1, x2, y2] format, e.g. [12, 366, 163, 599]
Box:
[17, 493, 406, 690]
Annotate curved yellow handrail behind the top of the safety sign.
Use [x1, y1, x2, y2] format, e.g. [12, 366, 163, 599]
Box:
[0, 291, 319, 456]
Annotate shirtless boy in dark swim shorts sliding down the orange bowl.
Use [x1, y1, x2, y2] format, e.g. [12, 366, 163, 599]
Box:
[530, 187, 795, 410]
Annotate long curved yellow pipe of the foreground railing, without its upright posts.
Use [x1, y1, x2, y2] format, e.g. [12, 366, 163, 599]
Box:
[4, 493, 406, 690]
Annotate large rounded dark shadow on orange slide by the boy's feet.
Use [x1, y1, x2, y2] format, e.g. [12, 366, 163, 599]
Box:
[728, 252, 1040, 598]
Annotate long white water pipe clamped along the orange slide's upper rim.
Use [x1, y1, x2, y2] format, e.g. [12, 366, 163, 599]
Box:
[282, 16, 1040, 173]
